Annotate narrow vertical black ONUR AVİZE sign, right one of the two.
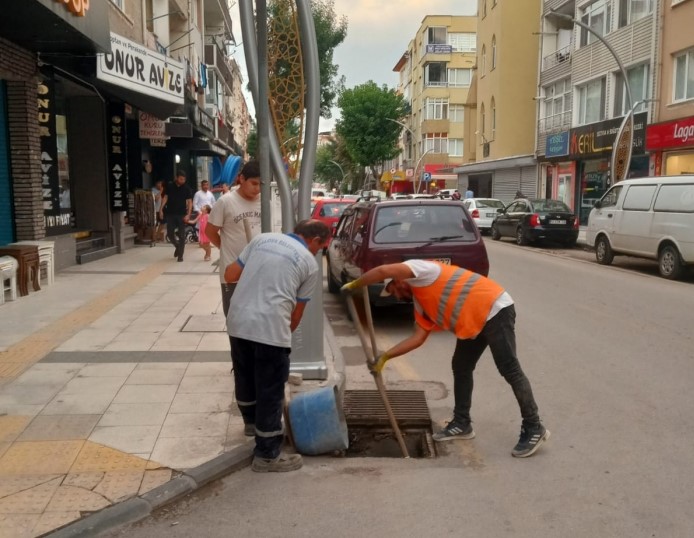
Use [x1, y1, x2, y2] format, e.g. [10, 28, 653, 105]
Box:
[108, 103, 128, 211]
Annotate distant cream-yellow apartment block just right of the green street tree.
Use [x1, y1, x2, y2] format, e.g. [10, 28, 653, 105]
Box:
[392, 15, 477, 192]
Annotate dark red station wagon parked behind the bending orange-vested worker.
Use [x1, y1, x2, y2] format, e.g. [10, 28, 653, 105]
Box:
[327, 199, 489, 304]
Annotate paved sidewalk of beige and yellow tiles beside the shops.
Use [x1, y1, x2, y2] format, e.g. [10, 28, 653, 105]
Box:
[0, 246, 338, 538]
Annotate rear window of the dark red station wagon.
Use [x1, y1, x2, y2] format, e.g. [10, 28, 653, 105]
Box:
[373, 204, 476, 243]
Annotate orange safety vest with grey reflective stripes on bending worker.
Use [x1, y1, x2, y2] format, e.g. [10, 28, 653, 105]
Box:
[412, 262, 504, 340]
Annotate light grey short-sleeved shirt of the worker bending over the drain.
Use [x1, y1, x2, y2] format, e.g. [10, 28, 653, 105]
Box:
[227, 233, 318, 347]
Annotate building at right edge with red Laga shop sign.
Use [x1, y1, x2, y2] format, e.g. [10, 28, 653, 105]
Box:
[646, 0, 694, 175]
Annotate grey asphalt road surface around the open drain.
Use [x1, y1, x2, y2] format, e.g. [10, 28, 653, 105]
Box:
[103, 241, 694, 538]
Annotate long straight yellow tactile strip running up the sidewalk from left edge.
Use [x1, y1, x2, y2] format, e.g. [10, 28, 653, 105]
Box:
[0, 260, 170, 379]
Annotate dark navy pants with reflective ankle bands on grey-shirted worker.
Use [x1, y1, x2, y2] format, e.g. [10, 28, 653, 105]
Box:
[231, 336, 291, 459]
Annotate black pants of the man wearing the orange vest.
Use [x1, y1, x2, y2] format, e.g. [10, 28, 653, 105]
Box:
[453, 305, 540, 427]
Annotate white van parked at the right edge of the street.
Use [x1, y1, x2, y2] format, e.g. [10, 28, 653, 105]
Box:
[586, 175, 694, 279]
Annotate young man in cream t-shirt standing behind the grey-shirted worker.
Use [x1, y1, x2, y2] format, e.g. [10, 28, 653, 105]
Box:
[205, 161, 260, 318]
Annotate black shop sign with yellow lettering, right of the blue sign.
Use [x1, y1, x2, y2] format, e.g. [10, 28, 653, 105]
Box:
[569, 112, 647, 159]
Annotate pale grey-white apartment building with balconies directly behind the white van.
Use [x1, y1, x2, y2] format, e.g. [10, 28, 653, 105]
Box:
[536, 0, 670, 225]
